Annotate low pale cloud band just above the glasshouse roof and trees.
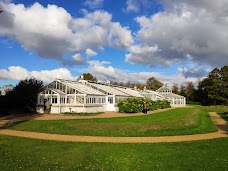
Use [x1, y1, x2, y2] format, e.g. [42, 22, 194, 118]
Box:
[80, 61, 191, 85]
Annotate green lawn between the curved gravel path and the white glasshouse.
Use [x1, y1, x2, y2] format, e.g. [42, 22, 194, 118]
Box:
[9, 107, 217, 136]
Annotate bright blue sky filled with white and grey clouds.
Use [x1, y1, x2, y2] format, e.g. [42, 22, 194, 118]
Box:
[0, 0, 228, 86]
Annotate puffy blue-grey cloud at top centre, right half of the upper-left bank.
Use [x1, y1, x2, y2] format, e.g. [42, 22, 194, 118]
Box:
[72, 11, 133, 50]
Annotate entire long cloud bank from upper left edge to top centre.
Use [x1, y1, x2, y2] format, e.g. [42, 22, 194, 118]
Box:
[0, 3, 133, 63]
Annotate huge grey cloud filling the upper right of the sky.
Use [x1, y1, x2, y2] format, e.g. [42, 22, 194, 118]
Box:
[126, 0, 228, 67]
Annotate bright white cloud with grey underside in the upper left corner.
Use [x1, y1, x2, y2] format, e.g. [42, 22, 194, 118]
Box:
[0, 3, 73, 60]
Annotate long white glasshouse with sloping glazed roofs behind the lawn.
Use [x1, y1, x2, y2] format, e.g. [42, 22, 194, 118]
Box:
[37, 79, 185, 113]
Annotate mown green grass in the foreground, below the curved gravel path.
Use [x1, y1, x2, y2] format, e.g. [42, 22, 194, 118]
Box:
[0, 135, 228, 171]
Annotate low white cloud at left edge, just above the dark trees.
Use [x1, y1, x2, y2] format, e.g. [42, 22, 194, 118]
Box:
[0, 66, 76, 83]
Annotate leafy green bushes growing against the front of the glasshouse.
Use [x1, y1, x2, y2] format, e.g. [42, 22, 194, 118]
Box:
[118, 97, 170, 113]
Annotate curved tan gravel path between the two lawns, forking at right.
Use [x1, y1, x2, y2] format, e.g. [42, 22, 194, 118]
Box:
[0, 112, 228, 143]
